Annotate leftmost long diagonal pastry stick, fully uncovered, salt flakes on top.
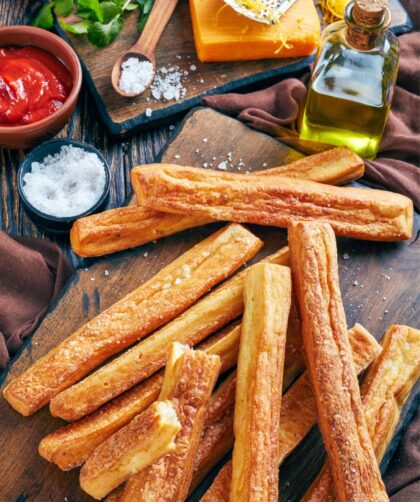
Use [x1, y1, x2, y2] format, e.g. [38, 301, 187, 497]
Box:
[3, 225, 262, 415]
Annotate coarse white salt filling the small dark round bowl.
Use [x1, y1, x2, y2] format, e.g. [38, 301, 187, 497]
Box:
[22, 145, 106, 217]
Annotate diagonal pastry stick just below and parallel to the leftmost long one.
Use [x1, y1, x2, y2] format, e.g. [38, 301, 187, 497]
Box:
[50, 248, 289, 421]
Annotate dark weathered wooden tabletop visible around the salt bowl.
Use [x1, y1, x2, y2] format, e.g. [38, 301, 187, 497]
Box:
[0, 0, 172, 266]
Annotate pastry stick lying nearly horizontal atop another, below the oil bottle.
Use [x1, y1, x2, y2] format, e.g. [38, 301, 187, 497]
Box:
[131, 164, 413, 241]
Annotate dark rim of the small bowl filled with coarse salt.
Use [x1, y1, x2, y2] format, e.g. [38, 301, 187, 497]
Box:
[17, 138, 111, 223]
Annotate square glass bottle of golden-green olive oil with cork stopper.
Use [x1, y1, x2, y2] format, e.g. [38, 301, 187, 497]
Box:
[300, 0, 399, 159]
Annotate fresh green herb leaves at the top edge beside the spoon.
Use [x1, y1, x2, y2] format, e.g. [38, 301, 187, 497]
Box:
[33, 0, 154, 47]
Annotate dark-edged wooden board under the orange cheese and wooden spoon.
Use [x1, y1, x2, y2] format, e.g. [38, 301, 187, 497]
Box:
[56, 0, 412, 135]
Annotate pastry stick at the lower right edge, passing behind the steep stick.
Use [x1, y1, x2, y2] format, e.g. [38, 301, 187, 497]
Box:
[304, 325, 420, 502]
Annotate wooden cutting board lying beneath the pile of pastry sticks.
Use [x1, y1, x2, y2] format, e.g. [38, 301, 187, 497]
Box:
[0, 108, 420, 502]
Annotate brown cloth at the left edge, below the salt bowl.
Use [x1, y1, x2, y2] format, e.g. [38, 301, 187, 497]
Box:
[0, 232, 73, 371]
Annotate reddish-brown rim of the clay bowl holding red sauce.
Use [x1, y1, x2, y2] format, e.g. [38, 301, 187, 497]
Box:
[0, 25, 82, 134]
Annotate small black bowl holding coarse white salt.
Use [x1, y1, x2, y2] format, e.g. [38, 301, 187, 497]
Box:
[17, 139, 110, 234]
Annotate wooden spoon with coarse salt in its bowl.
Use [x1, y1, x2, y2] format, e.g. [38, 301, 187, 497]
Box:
[111, 0, 178, 98]
